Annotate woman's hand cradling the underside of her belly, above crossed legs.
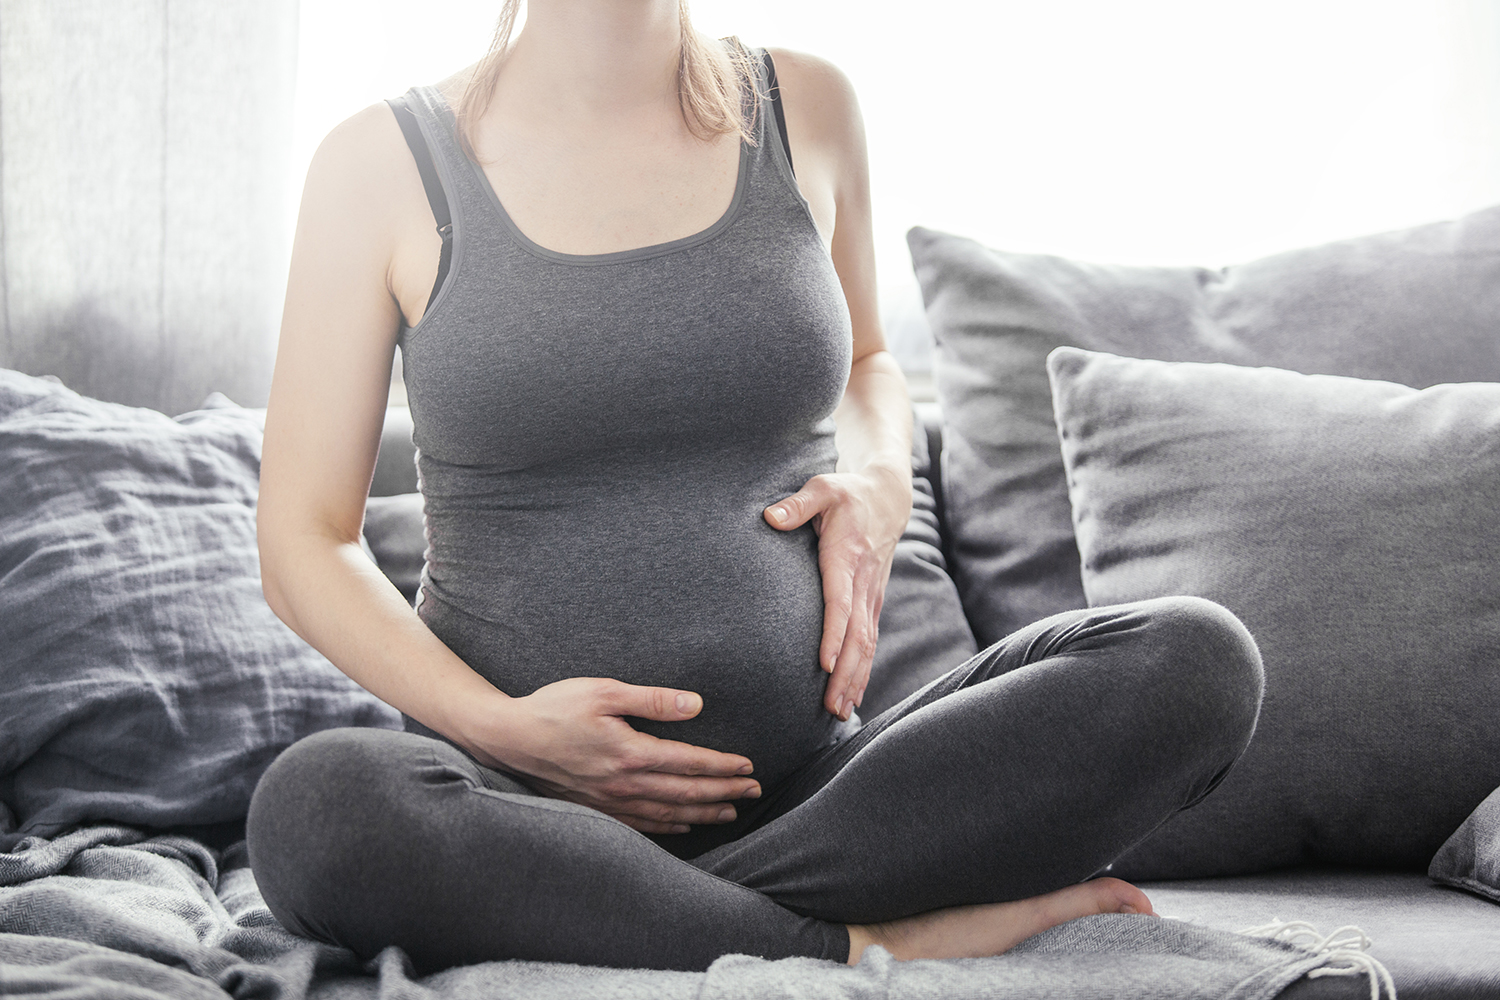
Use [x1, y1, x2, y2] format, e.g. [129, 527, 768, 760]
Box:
[464, 678, 761, 834]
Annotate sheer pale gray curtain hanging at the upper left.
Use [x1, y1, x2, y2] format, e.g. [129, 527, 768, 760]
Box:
[0, 0, 297, 414]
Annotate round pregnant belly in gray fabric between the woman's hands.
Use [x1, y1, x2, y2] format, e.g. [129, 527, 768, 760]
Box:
[420, 493, 839, 786]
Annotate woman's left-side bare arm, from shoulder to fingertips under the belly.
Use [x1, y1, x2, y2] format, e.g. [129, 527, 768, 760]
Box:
[257, 105, 758, 832]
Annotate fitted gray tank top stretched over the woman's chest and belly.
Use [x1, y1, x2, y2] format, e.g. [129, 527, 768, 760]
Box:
[401, 52, 852, 786]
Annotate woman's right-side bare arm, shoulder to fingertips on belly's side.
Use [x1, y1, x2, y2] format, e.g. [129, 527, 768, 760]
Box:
[767, 49, 912, 718]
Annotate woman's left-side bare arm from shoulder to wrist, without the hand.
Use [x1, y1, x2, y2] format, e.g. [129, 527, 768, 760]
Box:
[257, 106, 497, 733]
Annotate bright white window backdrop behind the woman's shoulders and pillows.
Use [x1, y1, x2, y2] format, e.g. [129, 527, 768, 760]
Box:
[288, 0, 1500, 369]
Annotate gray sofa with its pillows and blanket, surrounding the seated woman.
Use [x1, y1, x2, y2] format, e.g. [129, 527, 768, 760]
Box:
[0, 208, 1500, 1000]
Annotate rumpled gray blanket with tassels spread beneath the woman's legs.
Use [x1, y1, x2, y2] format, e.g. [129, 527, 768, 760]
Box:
[0, 826, 1368, 1000]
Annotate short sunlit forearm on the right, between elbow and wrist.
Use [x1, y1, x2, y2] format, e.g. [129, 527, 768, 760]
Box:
[834, 351, 912, 488]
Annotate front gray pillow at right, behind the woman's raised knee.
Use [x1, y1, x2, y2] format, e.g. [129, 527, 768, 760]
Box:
[1049, 348, 1500, 879]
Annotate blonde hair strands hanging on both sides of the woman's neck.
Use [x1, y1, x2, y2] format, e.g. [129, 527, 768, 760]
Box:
[456, 0, 761, 156]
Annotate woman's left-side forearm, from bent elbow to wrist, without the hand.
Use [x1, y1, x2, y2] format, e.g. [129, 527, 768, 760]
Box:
[261, 520, 513, 751]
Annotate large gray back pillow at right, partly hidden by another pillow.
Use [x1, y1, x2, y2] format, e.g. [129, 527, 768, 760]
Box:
[908, 207, 1500, 645]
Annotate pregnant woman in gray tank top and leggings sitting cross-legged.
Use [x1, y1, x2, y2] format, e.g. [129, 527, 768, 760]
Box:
[249, 0, 1262, 970]
